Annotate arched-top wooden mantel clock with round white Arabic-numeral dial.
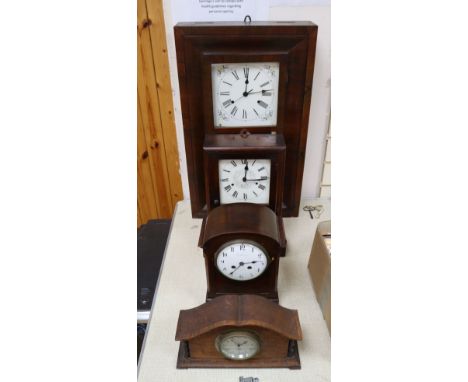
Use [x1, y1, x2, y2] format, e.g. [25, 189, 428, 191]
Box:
[198, 203, 286, 301]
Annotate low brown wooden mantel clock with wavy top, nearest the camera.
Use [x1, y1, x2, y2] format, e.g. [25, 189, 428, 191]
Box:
[175, 295, 302, 369]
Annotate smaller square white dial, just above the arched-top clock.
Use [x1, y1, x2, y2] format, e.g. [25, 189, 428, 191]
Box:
[219, 159, 271, 204]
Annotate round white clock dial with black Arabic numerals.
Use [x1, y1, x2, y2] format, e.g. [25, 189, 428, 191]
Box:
[216, 240, 268, 281]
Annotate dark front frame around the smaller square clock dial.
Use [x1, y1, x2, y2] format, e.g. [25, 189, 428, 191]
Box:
[203, 136, 285, 216]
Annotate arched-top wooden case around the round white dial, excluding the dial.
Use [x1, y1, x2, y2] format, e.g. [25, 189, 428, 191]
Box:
[198, 203, 286, 302]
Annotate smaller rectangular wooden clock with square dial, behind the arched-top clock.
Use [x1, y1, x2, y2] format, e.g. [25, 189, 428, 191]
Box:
[203, 134, 286, 215]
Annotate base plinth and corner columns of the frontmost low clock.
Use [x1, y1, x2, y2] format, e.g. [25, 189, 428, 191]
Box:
[177, 340, 301, 369]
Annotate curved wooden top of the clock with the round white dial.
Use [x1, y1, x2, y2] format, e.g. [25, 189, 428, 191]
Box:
[199, 203, 286, 249]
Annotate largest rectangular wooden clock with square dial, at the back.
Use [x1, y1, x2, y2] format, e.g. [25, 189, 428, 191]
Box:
[174, 22, 317, 217]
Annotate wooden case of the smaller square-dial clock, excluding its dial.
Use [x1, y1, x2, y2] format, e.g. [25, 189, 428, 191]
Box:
[203, 134, 286, 216]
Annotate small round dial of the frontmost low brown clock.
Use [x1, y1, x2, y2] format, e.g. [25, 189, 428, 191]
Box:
[215, 330, 260, 361]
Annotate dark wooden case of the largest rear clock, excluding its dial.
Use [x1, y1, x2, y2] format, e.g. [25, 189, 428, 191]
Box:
[174, 22, 317, 217]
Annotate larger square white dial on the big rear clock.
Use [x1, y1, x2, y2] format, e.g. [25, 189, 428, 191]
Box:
[211, 62, 279, 128]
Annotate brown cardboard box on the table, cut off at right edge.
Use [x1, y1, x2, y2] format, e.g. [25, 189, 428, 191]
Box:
[307, 220, 331, 334]
